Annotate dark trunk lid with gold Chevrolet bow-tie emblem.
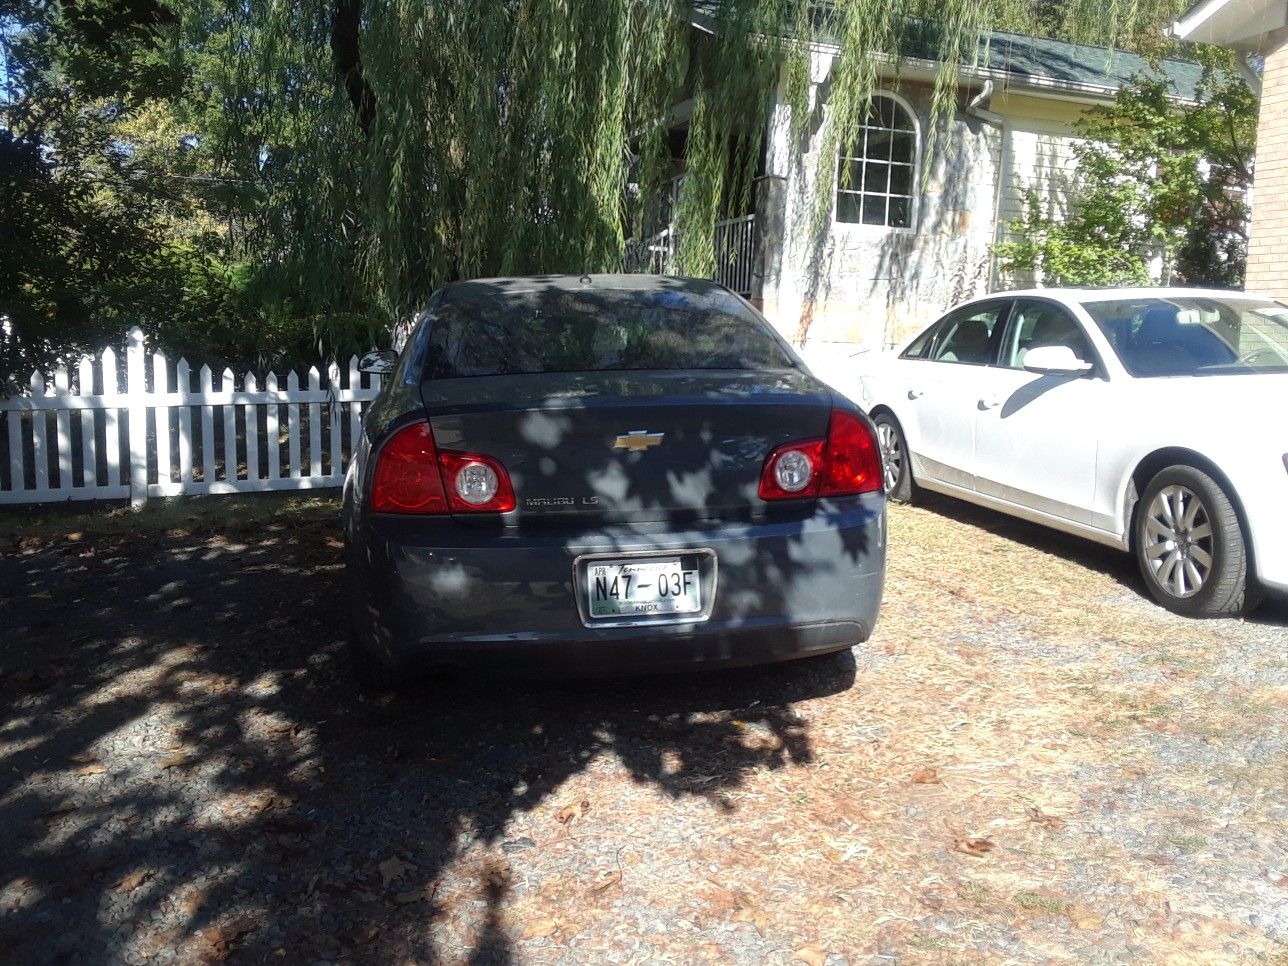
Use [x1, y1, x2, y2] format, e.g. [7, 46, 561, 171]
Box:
[421, 370, 832, 523]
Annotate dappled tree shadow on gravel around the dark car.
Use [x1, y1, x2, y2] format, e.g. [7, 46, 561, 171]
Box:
[0, 516, 854, 962]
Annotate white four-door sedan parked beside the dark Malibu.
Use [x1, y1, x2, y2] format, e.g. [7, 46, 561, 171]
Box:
[862, 289, 1288, 617]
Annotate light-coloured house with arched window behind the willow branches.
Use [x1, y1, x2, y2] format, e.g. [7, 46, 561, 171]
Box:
[650, 25, 1200, 372]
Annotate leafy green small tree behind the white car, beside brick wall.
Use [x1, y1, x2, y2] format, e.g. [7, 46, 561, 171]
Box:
[994, 52, 1257, 286]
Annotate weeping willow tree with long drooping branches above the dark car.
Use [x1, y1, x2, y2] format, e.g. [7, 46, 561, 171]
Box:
[176, 0, 1158, 352]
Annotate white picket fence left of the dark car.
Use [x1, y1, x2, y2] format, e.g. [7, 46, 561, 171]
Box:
[0, 327, 380, 506]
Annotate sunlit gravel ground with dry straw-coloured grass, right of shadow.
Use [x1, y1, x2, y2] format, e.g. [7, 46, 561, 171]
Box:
[486, 506, 1288, 962]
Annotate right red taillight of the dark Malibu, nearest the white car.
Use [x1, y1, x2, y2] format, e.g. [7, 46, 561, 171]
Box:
[759, 410, 882, 500]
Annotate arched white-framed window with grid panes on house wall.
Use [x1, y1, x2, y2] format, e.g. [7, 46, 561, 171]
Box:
[836, 94, 917, 228]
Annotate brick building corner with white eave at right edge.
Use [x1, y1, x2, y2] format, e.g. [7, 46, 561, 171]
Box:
[1168, 0, 1288, 301]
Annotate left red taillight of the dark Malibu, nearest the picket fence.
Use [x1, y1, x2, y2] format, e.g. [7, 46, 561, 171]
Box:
[371, 422, 515, 514]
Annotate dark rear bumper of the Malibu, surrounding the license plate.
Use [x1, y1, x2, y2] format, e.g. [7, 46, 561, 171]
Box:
[346, 495, 885, 676]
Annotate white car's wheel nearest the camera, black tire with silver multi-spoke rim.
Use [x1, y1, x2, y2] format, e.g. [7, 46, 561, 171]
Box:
[1132, 465, 1261, 617]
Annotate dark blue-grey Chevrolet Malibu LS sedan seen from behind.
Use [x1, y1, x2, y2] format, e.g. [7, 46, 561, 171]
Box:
[344, 276, 885, 688]
